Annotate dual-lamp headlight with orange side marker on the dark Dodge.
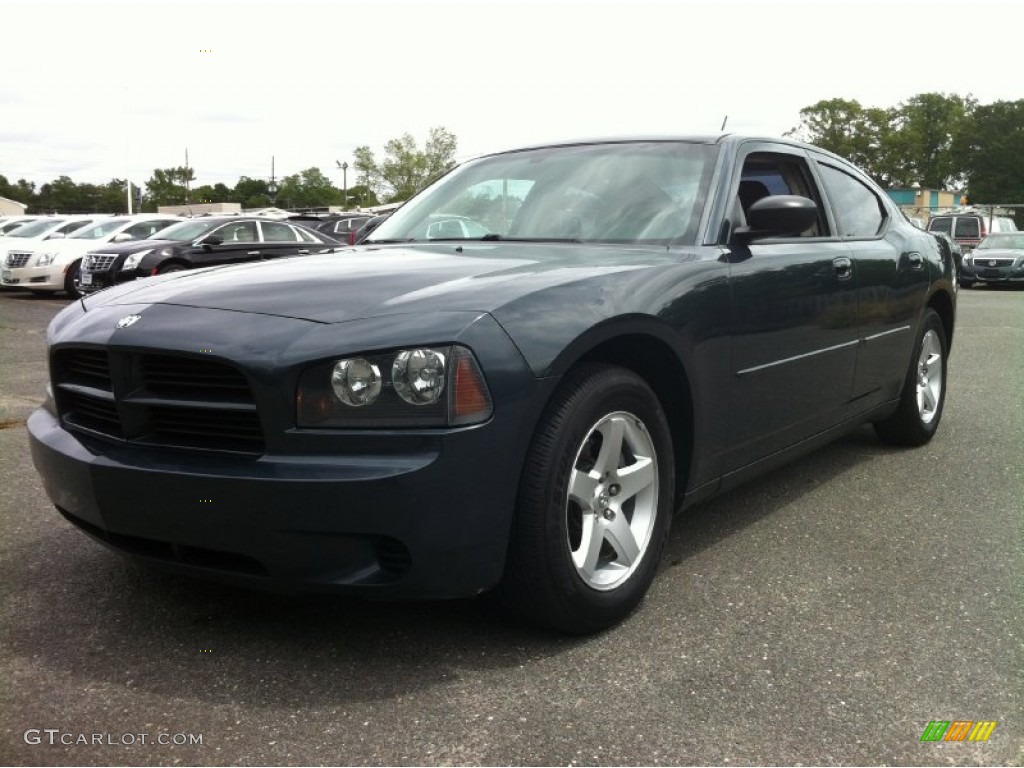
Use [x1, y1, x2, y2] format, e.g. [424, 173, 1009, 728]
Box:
[296, 346, 493, 428]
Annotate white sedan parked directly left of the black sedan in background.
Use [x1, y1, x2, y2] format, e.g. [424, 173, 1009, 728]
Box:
[0, 219, 183, 298]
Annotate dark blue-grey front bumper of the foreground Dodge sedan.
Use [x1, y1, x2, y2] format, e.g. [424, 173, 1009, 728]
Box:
[28, 307, 554, 598]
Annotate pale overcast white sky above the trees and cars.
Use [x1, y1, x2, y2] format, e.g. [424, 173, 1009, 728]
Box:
[0, 0, 1024, 187]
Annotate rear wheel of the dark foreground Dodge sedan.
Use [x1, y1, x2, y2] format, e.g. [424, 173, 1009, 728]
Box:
[874, 309, 949, 445]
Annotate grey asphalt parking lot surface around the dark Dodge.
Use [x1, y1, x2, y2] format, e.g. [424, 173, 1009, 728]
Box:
[0, 288, 1024, 765]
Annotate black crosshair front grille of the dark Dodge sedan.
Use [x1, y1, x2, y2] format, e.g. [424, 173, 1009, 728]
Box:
[51, 347, 264, 454]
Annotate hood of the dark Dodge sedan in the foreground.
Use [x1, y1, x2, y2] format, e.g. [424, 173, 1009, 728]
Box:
[84, 243, 685, 323]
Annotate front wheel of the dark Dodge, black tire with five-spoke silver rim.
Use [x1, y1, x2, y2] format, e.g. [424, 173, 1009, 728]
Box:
[498, 366, 675, 634]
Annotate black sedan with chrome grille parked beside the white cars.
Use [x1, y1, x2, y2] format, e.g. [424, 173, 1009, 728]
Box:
[80, 216, 341, 293]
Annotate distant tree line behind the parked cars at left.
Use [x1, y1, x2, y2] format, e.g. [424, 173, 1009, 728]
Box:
[0, 127, 458, 213]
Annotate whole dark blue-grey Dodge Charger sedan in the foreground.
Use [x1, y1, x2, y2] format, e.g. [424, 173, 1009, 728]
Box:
[34, 135, 956, 633]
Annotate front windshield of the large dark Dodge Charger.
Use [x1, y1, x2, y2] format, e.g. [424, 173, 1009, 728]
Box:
[367, 141, 717, 244]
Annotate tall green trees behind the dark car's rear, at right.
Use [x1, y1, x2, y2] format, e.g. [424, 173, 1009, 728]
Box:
[786, 93, 1024, 204]
